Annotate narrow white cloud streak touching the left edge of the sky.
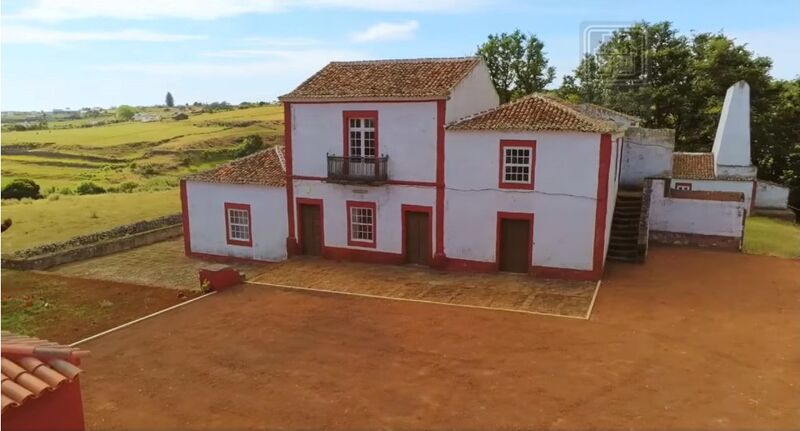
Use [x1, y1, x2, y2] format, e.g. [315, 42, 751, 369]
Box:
[2, 25, 206, 45]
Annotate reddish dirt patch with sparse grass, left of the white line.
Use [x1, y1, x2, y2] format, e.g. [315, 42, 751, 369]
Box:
[2, 271, 196, 344]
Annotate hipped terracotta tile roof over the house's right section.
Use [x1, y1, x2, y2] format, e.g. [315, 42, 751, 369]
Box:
[447, 94, 617, 133]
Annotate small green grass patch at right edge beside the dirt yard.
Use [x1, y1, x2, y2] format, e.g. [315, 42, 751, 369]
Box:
[744, 216, 800, 259]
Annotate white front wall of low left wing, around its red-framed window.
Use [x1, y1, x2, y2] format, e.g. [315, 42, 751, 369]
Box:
[186, 181, 288, 261]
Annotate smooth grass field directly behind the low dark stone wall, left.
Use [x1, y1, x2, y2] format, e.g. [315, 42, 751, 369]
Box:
[2, 189, 181, 253]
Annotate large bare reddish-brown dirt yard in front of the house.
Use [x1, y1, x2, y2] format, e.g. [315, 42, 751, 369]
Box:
[82, 248, 800, 430]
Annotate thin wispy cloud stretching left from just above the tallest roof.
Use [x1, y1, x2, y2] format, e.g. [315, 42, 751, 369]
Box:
[91, 49, 369, 78]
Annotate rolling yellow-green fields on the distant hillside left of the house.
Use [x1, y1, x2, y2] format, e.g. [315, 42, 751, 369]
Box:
[2, 105, 283, 193]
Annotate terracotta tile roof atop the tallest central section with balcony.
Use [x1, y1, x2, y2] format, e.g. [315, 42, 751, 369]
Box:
[279, 57, 481, 101]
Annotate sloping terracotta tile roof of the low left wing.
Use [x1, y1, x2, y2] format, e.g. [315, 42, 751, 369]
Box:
[186, 145, 286, 187]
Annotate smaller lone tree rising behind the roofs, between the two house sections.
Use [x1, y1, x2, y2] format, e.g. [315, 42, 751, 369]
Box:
[477, 30, 556, 103]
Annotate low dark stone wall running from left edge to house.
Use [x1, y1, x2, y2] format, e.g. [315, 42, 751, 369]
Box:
[2, 214, 183, 270]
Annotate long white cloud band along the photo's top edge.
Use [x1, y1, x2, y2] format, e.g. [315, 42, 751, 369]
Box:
[6, 0, 488, 22]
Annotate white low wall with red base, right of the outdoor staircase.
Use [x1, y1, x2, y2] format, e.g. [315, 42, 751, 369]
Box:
[646, 179, 746, 250]
